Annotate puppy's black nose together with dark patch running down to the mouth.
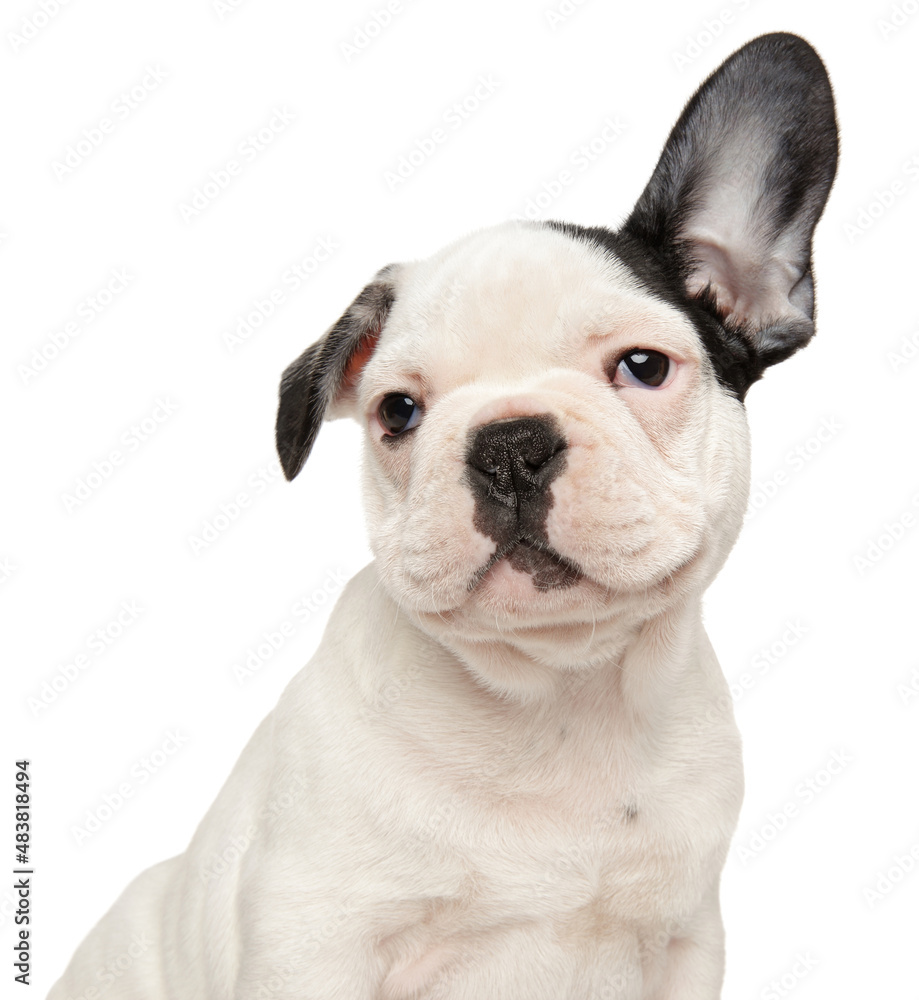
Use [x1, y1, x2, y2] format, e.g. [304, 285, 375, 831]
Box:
[466, 414, 581, 590]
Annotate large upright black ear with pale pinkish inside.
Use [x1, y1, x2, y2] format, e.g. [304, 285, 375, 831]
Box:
[623, 34, 837, 382]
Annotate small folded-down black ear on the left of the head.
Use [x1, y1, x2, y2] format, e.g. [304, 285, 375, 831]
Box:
[275, 264, 398, 479]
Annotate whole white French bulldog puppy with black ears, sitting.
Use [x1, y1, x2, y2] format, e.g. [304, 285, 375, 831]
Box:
[51, 34, 837, 1000]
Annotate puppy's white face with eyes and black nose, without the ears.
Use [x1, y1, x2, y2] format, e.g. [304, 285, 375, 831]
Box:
[344, 224, 745, 640]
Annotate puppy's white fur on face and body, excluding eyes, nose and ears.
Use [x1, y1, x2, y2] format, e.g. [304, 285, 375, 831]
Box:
[51, 223, 748, 1000]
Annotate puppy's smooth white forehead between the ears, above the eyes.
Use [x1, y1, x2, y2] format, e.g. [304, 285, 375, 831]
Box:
[373, 223, 700, 382]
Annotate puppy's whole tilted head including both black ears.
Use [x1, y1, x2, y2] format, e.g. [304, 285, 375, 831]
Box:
[277, 29, 837, 690]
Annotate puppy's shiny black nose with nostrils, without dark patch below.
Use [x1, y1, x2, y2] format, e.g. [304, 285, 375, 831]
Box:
[466, 415, 565, 517]
